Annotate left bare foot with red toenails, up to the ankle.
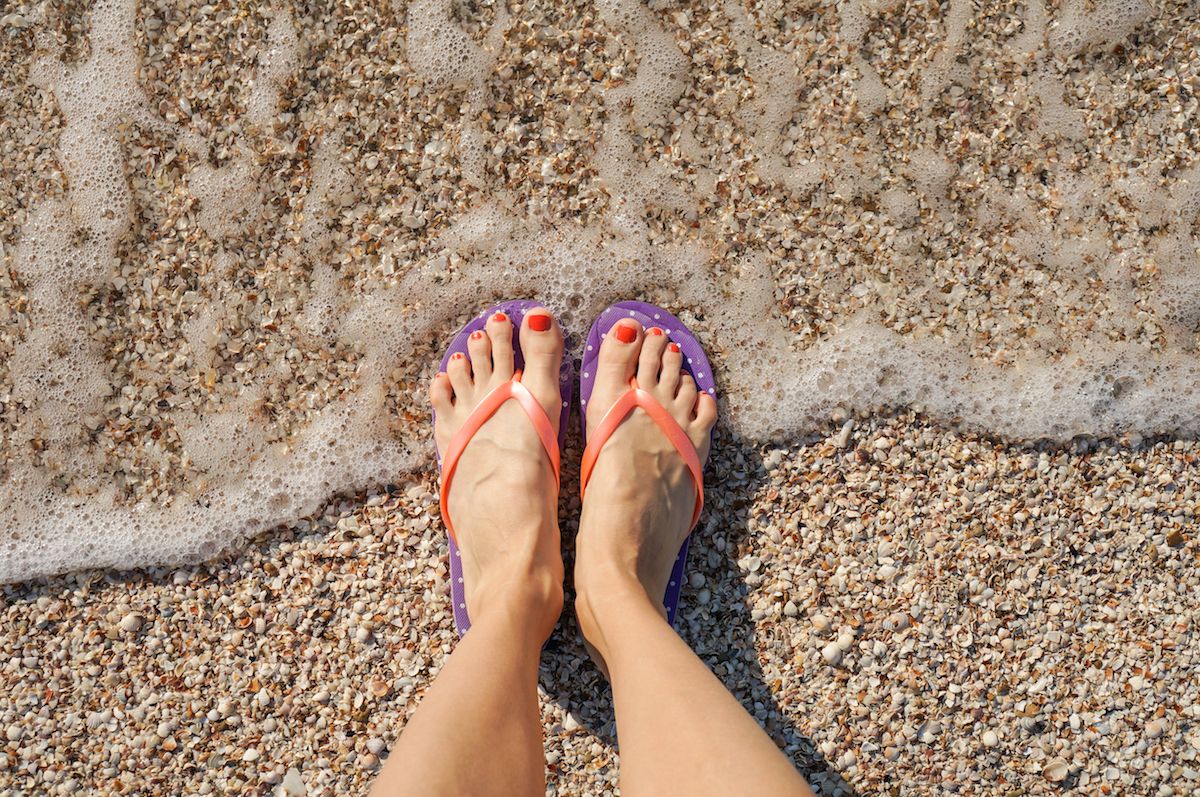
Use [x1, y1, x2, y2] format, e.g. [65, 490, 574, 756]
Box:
[430, 307, 563, 636]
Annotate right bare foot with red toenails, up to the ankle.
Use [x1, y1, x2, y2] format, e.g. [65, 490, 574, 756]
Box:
[575, 318, 716, 669]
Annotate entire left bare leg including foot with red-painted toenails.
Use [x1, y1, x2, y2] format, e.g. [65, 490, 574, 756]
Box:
[371, 311, 563, 797]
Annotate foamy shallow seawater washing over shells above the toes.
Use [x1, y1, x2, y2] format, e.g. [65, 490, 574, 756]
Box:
[0, 0, 1200, 581]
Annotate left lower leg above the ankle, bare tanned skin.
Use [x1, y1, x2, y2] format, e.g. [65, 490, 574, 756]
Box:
[371, 573, 562, 797]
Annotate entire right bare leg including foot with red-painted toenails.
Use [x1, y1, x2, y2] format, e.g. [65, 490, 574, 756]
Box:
[575, 319, 812, 797]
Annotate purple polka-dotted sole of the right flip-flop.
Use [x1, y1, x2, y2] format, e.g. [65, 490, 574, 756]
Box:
[580, 301, 716, 625]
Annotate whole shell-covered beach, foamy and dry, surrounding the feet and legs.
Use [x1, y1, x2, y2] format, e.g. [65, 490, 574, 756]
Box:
[0, 0, 1200, 797]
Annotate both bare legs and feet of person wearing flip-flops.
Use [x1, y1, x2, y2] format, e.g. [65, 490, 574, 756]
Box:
[372, 308, 812, 797]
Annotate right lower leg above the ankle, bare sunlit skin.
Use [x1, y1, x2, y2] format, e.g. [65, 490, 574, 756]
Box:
[576, 574, 812, 797]
